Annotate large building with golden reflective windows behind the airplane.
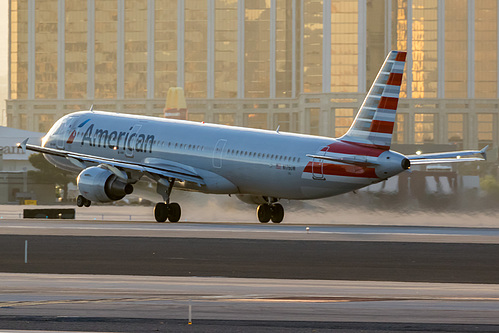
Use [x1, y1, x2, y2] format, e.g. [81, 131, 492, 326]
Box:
[7, 0, 499, 149]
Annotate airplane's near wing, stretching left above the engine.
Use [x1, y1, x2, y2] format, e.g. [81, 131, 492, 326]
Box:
[17, 139, 205, 185]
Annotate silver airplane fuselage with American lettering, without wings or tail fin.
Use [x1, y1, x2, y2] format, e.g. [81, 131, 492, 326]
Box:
[43, 111, 403, 200]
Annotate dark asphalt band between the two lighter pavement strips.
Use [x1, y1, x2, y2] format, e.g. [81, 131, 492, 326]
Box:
[0, 235, 499, 284]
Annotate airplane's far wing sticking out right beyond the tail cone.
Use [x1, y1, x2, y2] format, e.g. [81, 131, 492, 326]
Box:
[407, 146, 489, 165]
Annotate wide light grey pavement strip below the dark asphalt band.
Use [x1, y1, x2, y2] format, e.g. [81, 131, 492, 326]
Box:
[0, 274, 499, 332]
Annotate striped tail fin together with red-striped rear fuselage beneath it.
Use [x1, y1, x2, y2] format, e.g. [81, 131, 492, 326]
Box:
[302, 51, 407, 180]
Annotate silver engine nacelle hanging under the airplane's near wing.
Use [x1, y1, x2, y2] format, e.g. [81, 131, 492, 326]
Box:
[76, 167, 133, 202]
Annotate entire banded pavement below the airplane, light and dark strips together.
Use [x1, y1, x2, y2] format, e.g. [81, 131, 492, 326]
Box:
[0, 219, 499, 332]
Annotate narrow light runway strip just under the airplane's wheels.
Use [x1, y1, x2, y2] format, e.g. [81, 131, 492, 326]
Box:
[0, 219, 499, 244]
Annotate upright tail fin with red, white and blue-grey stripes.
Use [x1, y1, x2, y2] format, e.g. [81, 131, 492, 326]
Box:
[339, 51, 407, 150]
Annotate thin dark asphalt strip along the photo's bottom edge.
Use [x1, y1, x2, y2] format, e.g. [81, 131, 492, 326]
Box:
[0, 316, 499, 333]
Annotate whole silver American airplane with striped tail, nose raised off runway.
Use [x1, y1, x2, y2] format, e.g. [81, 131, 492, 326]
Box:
[18, 51, 487, 223]
